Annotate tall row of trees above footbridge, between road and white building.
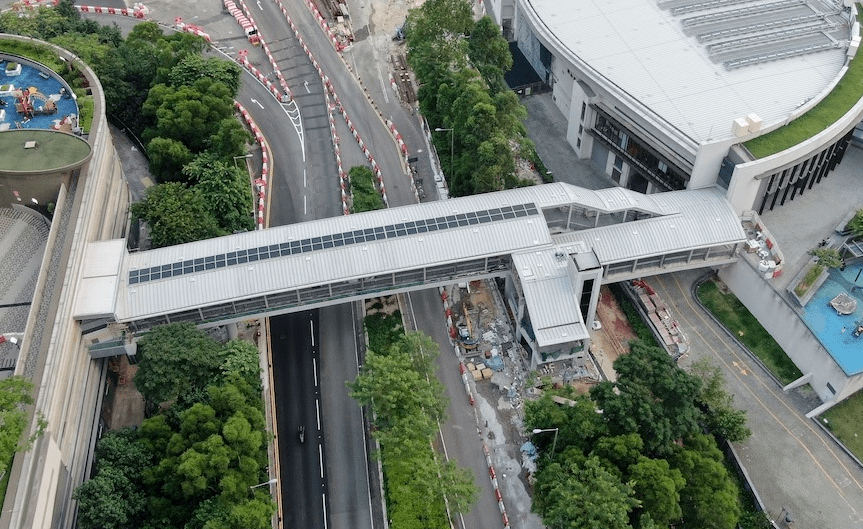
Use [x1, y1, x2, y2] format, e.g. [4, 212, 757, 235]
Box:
[405, 0, 541, 196]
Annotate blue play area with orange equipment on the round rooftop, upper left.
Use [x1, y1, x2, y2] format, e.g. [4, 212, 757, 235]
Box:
[0, 60, 78, 130]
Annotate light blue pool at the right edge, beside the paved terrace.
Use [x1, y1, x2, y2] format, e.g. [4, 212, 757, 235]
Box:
[803, 260, 863, 375]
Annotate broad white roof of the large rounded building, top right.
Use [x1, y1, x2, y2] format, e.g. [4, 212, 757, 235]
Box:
[525, 0, 850, 144]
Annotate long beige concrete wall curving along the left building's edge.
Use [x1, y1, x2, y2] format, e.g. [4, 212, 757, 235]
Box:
[0, 35, 129, 529]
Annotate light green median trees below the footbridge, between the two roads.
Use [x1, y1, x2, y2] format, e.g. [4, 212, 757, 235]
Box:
[348, 326, 478, 529]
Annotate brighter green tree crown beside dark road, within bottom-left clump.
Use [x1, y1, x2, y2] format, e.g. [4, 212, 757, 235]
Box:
[139, 371, 274, 527]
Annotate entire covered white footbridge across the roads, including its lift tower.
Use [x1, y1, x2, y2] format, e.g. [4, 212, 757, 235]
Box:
[74, 183, 745, 356]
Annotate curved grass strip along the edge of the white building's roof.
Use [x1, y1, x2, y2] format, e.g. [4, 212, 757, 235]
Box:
[744, 10, 863, 158]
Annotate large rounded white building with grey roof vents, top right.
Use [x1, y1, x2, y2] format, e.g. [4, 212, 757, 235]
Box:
[486, 0, 863, 213]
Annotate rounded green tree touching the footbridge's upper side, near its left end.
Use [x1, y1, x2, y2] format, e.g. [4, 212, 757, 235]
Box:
[132, 182, 225, 248]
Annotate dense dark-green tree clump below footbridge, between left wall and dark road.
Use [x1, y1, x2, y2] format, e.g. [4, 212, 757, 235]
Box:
[74, 324, 275, 529]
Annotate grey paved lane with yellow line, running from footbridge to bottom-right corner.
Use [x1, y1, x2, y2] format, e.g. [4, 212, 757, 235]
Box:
[647, 270, 863, 529]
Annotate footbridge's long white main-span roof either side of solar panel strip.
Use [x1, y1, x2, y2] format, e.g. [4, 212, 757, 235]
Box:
[109, 193, 551, 321]
